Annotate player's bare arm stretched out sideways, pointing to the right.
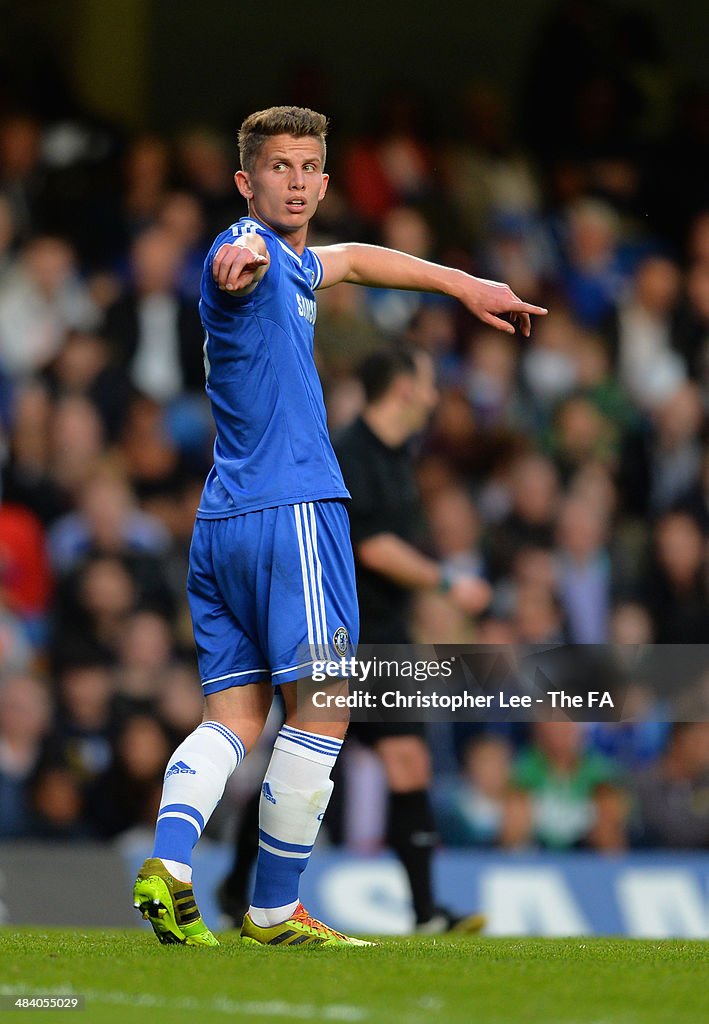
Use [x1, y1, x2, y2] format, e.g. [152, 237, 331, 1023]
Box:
[312, 242, 547, 337]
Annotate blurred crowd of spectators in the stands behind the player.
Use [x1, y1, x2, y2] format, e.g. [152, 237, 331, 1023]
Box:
[0, 3, 709, 850]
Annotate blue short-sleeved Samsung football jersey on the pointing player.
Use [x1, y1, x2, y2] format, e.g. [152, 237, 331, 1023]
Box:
[197, 217, 349, 519]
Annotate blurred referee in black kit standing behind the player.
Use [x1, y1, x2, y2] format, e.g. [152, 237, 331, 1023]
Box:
[334, 348, 490, 934]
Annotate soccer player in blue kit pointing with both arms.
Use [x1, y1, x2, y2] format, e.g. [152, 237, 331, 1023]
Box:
[134, 106, 546, 946]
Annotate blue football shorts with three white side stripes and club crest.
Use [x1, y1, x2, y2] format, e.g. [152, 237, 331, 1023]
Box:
[187, 501, 360, 693]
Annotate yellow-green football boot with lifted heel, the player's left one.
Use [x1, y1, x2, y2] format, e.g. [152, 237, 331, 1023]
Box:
[133, 857, 219, 946]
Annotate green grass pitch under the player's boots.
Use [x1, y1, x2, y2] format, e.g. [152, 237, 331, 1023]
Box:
[0, 928, 709, 1024]
